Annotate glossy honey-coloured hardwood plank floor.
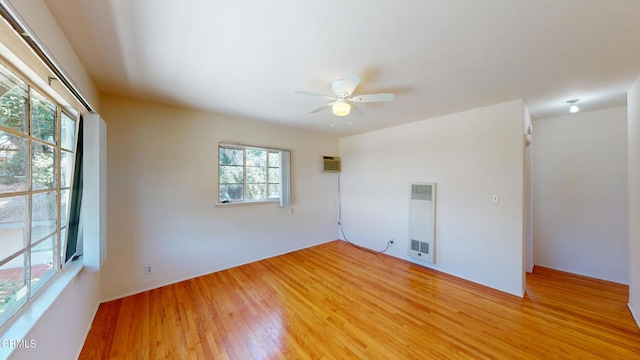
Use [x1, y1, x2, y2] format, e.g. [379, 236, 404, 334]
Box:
[80, 241, 640, 360]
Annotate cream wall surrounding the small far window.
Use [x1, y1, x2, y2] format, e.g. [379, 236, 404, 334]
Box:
[101, 97, 338, 300]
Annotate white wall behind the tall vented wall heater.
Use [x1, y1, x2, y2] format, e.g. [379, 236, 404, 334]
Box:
[340, 100, 524, 296]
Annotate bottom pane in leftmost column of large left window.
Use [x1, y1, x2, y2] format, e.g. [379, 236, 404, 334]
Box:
[0, 254, 27, 324]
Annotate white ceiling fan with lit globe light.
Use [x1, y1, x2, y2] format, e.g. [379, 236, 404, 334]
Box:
[294, 75, 394, 116]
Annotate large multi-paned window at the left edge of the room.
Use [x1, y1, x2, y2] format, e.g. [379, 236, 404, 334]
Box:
[0, 65, 76, 325]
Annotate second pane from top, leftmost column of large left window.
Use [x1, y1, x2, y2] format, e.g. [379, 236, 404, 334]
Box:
[0, 131, 29, 193]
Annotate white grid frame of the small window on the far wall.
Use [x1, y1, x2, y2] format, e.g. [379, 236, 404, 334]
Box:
[217, 143, 287, 206]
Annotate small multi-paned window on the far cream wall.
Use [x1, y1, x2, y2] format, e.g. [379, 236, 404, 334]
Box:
[218, 144, 289, 204]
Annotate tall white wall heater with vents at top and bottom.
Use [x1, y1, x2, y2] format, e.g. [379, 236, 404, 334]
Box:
[409, 183, 436, 263]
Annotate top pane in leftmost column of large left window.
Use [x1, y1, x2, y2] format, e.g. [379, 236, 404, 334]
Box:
[0, 66, 27, 133]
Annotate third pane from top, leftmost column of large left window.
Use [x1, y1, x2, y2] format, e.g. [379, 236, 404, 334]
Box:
[0, 195, 27, 260]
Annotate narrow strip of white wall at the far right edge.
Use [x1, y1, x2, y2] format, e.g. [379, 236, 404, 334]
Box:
[627, 78, 640, 326]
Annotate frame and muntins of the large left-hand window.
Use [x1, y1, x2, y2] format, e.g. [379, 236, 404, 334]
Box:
[0, 59, 79, 328]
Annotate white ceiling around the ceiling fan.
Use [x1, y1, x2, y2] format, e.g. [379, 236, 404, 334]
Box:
[45, 0, 640, 135]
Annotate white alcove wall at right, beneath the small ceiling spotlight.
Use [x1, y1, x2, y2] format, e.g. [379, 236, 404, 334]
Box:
[533, 107, 629, 284]
